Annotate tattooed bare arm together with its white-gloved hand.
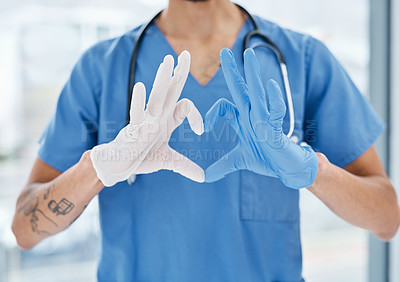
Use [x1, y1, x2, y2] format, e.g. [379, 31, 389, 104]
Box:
[12, 51, 204, 249]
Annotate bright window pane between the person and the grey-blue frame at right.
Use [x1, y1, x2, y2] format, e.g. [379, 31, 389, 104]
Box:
[241, 0, 369, 282]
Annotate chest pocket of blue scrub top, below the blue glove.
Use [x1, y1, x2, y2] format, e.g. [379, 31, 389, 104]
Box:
[239, 170, 300, 222]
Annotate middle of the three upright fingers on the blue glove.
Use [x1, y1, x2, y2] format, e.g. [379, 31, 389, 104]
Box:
[244, 48, 268, 121]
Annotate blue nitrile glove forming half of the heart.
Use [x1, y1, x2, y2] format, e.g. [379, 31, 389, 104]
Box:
[205, 49, 318, 189]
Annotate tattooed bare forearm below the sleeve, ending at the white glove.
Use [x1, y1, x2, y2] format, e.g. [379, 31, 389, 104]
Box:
[12, 152, 103, 249]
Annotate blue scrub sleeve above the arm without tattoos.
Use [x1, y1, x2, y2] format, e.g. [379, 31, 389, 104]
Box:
[304, 38, 384, 167]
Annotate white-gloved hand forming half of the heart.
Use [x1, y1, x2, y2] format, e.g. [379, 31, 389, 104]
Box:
[90, 51, 204, 186]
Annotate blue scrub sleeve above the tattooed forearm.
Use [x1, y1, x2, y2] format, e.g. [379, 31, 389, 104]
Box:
[38, 47, 100, 172]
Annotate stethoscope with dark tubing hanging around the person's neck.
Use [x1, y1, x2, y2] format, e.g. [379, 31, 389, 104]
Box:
[127, 4, 299, 184]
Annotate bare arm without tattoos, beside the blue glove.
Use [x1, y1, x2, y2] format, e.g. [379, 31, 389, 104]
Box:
[308, 147, 400, 241]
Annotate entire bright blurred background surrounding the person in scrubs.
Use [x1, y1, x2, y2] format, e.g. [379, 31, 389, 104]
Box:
[0, 0, 400, 282]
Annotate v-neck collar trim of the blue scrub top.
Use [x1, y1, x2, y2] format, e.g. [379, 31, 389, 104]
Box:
[153, 18, 249, 88]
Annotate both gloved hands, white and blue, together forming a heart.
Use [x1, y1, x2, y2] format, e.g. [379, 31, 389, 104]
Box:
[90, 49, 318, 189]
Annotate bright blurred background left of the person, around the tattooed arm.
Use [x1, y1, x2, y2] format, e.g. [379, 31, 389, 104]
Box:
[0, 1, 160, 282]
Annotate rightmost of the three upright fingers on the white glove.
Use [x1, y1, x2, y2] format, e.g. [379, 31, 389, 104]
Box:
[164, 50, 190, 111]
